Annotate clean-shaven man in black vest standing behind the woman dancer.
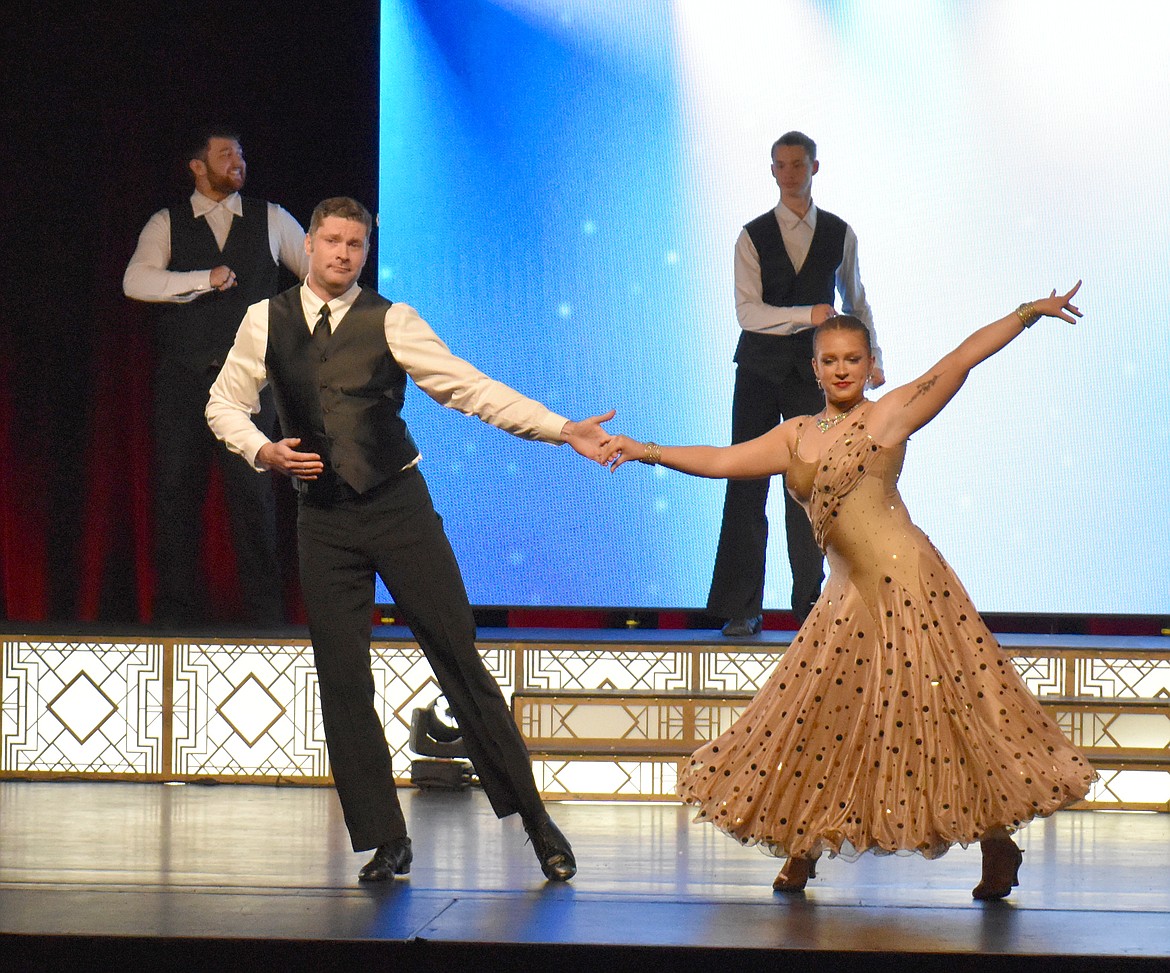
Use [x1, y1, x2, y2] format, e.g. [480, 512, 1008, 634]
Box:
[707, 132, 885, 637]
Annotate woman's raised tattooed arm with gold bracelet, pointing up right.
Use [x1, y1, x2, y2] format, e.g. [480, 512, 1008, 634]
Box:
[868, 281, 1081, 446]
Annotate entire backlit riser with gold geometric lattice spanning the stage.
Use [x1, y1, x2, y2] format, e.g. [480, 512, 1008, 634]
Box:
[0, 630, 1170, 810]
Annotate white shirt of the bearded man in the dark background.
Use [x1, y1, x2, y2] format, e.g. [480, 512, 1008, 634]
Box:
[122, 191, 309, 298]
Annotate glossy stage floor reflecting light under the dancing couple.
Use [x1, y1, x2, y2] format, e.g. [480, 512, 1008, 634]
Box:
[0, 781, 1170, 969]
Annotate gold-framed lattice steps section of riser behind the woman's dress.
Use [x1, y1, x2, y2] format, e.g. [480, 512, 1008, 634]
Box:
[512, 637, 1170, 810]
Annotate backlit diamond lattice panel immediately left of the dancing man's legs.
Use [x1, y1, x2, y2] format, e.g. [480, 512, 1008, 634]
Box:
[172, 642, 329, 780]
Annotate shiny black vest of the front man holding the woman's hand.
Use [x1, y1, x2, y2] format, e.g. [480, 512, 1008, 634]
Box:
[264, 285, 419, 501]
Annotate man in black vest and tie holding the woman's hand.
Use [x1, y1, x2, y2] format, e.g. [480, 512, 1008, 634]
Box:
[207, 196, 613, 882]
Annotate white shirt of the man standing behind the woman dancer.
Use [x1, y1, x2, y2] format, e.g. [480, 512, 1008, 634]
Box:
[735, 202, 881, 368]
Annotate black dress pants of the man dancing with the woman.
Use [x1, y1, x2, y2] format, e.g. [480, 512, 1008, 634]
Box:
[297, 469, 543, 851]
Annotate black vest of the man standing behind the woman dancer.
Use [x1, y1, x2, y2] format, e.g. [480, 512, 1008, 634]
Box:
[735, 209, 846, 375]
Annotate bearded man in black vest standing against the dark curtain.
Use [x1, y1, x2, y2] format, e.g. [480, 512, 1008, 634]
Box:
[123, 130, 308, 628]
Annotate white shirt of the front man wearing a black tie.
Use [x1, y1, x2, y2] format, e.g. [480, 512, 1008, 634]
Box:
[207, 284, 569, 470]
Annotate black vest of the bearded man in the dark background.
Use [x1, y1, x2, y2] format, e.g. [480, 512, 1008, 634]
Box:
[158, 196, 280, 376]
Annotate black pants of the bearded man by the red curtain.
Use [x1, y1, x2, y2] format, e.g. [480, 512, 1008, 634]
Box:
[153, 360, 284, 628]
